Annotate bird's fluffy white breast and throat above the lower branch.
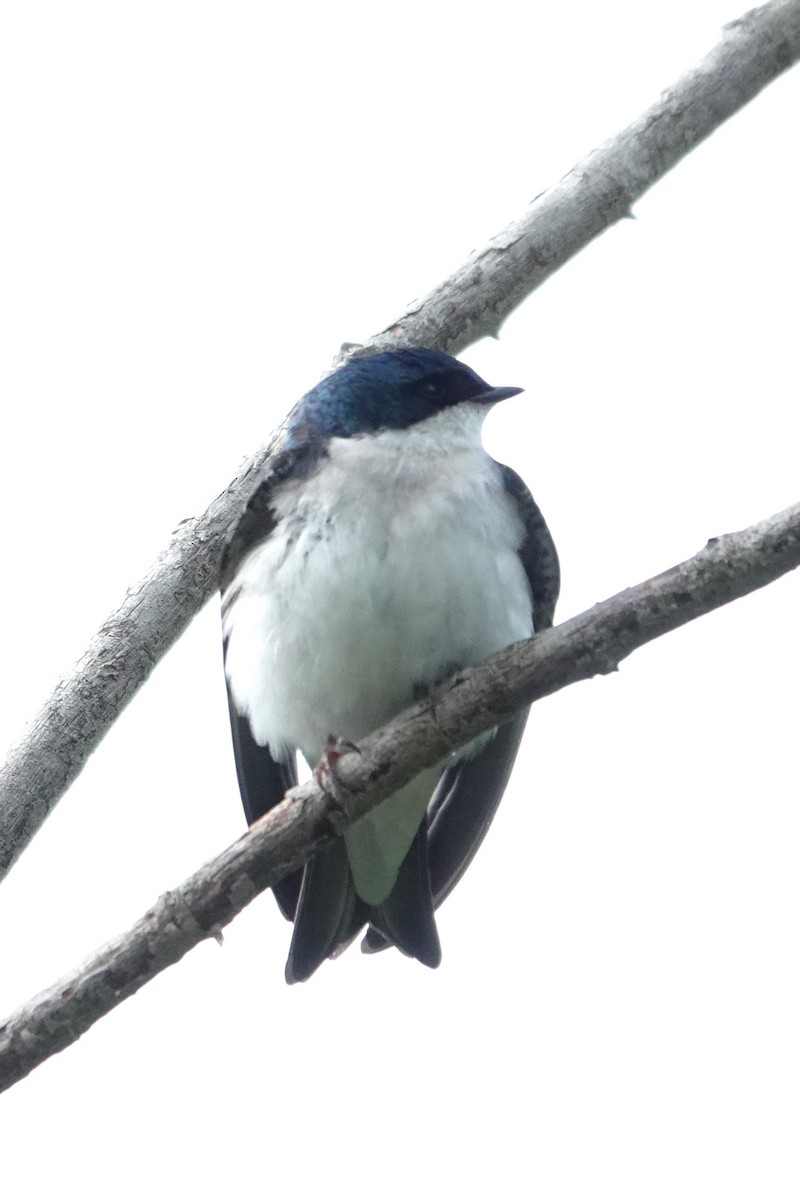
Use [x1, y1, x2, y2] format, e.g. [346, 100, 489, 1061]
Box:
[220, 404, 533, 762]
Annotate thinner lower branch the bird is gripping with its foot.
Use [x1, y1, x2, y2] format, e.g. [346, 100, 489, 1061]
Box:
[0, 504, 800, 1090]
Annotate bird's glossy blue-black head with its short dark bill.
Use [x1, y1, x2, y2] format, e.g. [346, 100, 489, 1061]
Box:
[287, 349, 522, 446]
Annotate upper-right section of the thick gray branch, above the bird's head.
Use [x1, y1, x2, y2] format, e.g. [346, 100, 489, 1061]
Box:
[360, 0, 800, 354]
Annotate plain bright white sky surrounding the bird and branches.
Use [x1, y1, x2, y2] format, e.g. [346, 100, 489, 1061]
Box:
[0, 0, 800, 1200]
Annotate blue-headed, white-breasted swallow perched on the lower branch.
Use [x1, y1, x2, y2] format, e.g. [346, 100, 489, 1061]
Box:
[222, 349, 559, 983]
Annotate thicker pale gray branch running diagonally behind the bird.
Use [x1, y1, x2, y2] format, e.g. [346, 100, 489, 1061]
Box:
[0, 0, 800, 878]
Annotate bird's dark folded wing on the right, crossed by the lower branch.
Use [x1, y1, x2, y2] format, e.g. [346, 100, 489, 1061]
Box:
[361, 467, 560, 954]
